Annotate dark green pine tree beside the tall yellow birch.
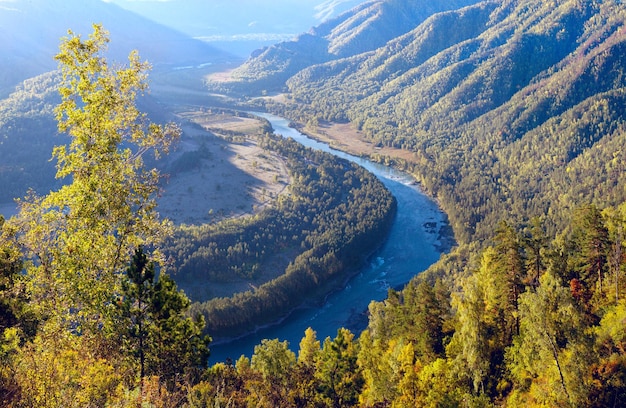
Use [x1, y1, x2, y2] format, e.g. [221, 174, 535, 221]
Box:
[115, 247, 210, 388]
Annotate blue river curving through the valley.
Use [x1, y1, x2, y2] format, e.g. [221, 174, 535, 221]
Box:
[209, 113, 447, 364]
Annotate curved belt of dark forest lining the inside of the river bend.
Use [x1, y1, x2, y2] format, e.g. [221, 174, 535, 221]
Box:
[165, 134, 396, 337]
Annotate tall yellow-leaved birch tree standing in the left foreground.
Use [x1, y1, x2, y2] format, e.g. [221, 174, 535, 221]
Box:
[10, 25, 180, 334]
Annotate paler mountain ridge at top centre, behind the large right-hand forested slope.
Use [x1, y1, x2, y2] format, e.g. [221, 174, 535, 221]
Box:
[217, 0, 478, 92]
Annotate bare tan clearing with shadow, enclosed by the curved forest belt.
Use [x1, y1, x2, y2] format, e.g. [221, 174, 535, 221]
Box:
[158, 106, 290, 225]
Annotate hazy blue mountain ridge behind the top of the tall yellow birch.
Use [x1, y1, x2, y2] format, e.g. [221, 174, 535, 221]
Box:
[0, 0, 233, 96]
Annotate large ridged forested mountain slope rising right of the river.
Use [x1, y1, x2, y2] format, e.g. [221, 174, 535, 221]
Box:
[272, 0, 626, 242]
